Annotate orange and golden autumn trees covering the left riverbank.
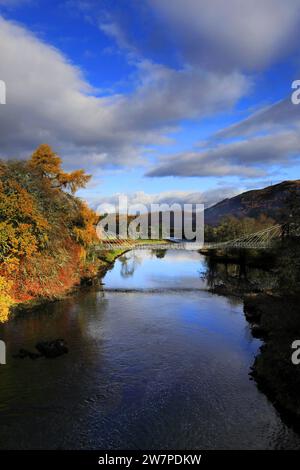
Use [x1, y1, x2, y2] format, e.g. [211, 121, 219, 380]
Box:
[0, 144, 97, 321]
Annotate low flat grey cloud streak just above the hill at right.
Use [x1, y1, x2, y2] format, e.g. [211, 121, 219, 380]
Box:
[148, 131, 300, 177]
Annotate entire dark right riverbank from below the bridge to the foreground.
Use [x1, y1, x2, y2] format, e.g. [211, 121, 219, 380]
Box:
[203, 244, 300, 424]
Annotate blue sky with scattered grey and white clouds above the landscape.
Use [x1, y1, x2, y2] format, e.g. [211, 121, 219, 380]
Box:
[0, 0, 300, 205]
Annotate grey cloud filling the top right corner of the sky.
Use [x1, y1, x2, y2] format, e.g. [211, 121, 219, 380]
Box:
[148, 0, 300, 70]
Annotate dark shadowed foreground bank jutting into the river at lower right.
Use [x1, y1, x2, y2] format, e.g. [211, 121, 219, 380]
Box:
[244, 294, 300, 424]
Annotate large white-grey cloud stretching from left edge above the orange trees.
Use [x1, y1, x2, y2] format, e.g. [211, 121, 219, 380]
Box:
[0, 17, 249, 173]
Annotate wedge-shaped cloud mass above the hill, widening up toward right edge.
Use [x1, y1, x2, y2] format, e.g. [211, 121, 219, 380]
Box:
[148, 85, 300, 177]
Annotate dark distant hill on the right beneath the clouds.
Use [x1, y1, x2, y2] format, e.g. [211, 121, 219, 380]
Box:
[205, 180, 300, 225]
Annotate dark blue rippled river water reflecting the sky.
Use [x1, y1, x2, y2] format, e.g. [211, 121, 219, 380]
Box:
[0, 250, 300, 449]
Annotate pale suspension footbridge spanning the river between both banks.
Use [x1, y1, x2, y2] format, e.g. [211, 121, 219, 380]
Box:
[97, 224, 285, 251]
